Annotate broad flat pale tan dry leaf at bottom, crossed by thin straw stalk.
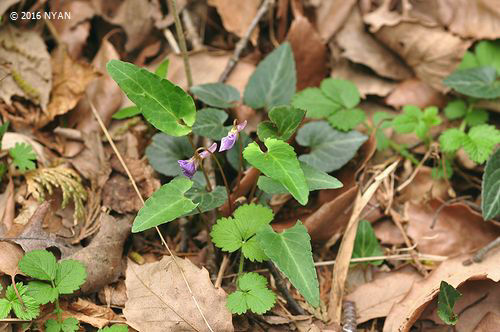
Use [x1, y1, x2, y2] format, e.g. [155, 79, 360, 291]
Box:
[123, 256, 233, 332]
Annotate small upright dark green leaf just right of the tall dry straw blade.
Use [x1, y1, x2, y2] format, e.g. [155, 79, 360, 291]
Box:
[352, 220, 383, 265]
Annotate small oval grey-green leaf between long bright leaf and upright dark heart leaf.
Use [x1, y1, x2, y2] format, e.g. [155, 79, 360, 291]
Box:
[191, 83, 240, 108]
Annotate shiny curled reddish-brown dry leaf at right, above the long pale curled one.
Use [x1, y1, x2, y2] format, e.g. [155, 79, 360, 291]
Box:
[405, 200, 500, 256]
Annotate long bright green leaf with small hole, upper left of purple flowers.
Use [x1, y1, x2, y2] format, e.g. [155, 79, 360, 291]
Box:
[106, 60, 196, 136]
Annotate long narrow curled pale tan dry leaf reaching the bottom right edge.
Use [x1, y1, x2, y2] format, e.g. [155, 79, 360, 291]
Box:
[383, 249, 500, 332]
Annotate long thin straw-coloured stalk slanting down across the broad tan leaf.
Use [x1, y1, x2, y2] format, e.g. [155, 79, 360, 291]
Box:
[87, 97, 213, 332]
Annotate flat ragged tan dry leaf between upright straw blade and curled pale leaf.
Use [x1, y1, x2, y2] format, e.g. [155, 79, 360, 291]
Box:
[346, 269, 422, 324]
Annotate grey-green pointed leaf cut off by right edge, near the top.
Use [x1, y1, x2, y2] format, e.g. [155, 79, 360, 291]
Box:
[443, 67, 500, 99]
